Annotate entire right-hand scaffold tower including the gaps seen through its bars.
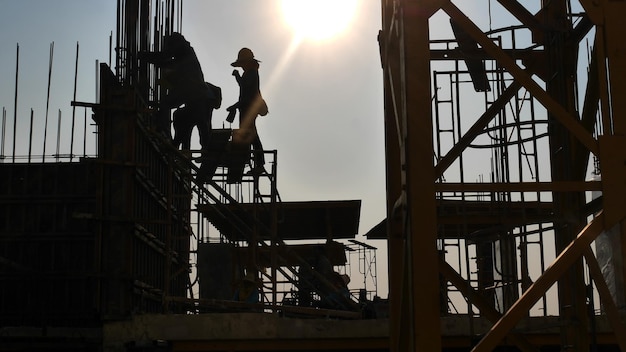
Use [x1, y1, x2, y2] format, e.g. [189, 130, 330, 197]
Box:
[379, 0, 624, 351]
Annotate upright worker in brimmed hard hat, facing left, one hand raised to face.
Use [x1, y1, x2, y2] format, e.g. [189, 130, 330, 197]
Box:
[226, 48, 268, 175]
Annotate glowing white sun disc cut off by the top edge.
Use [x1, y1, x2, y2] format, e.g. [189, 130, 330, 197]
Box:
[281, 0, 358, 41]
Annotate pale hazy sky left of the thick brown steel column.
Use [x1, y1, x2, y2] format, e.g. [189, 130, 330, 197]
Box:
[0, 0, 387, 297]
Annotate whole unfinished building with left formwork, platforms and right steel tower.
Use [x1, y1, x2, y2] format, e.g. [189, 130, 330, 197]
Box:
[0, 0, 626, 352]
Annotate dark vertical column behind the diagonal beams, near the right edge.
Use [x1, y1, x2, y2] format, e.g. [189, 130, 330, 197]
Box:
[539, 0, 590, 352]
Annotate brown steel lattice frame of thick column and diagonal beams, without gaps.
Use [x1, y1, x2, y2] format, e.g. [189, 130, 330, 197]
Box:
[379, 0, 626, 351]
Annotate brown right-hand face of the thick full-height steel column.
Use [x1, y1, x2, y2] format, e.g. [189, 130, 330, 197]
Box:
[400, 1, 441, 351]
